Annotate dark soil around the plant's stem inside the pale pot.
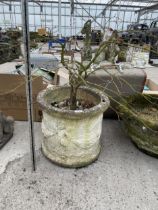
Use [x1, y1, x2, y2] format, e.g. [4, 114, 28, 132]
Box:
[51, 99, 96, 110]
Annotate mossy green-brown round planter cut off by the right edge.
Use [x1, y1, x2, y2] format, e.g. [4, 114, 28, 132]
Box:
[119, 95, 158, 157]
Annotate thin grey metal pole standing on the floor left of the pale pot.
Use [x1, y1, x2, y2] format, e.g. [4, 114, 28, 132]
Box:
[21, 0, 36, 171]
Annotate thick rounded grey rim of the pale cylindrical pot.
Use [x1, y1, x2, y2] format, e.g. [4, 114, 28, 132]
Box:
[37, 86, 110, 119]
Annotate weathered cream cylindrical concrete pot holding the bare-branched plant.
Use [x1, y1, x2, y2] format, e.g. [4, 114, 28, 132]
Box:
[38, 86, 109, 167]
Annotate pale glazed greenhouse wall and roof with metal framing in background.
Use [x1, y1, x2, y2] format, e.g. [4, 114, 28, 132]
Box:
[0, 0, 158, 36]
